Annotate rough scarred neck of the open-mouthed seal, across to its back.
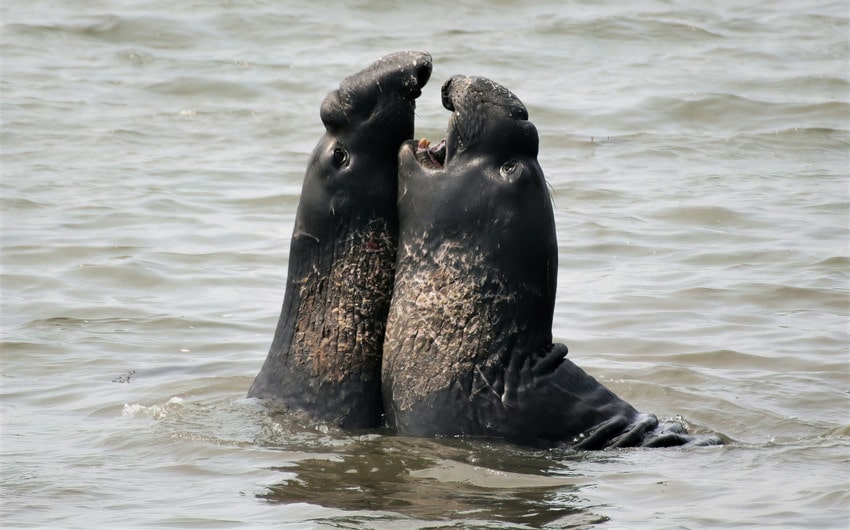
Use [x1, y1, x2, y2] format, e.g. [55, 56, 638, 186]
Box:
[384, 242, 552, 409]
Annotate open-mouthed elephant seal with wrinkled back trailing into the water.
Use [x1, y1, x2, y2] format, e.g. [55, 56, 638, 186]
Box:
[382, 76, 718, 449]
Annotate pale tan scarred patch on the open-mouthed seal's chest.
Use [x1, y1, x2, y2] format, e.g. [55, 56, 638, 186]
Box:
[384, 242, 512, 409]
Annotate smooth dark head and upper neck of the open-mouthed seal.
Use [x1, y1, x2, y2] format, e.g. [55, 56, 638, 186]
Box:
[398, 76, 558, 343]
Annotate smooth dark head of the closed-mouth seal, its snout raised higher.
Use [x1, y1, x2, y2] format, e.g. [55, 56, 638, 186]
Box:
[296, 52, 432, 233]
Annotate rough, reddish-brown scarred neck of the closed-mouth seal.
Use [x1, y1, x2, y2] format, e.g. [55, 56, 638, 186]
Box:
[272, 221, 396, 380]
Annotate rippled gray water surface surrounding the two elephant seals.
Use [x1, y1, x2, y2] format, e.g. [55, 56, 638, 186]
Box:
[0, 0, 850, 529]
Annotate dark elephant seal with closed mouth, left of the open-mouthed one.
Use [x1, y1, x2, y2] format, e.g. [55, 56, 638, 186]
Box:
[248, 52, 432, 428]
